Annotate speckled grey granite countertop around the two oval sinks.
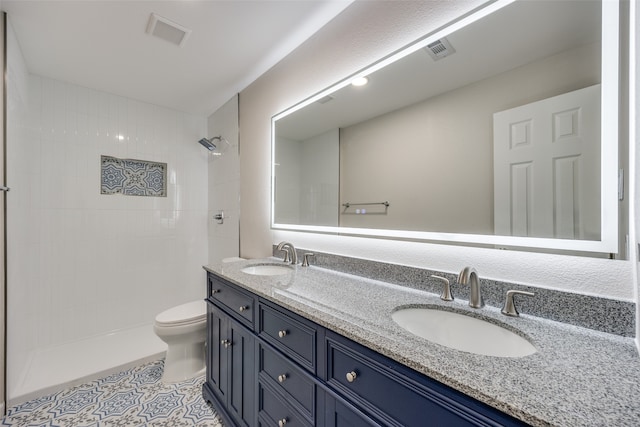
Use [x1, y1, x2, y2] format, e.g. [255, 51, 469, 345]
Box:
[205, 258, 640, 426]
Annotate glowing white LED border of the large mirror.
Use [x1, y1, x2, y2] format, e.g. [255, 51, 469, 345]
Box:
[271, 0, 620, 253]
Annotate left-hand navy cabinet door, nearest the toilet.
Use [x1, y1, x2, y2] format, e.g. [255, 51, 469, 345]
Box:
[207, 304, 229, 402]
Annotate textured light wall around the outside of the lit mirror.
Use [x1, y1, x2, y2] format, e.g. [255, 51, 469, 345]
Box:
[240, 0, 635, 300]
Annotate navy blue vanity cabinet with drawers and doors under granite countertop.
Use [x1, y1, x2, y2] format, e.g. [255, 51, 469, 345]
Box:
[203, 273, 526, 427]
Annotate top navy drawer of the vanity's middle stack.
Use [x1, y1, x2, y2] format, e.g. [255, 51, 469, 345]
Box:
[258, 303, 317, 373]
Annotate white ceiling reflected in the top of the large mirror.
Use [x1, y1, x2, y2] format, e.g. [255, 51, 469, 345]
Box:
[276, 1, 601, 141]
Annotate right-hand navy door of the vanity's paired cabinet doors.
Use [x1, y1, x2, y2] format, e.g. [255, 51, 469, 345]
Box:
[223, 318, 256, 426]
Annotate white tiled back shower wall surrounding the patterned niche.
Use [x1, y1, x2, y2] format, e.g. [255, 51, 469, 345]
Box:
[7, 25, 208, 398]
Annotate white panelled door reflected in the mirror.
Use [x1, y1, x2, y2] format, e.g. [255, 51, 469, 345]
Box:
[493, 85, 600, 240]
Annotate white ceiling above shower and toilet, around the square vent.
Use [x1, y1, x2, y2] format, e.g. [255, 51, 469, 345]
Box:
[1, 0, 353, 116]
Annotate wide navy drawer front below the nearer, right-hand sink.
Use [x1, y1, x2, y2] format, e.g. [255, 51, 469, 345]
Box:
[327, 338, 503, 427]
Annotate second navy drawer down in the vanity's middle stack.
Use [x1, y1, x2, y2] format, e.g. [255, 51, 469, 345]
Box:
[259, 344, 316, 419]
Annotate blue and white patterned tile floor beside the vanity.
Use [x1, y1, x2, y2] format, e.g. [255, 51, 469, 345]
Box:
[0, 360, 222, 427]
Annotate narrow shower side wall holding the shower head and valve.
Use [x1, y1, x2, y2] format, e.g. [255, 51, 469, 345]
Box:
[208, 95, 240, 263]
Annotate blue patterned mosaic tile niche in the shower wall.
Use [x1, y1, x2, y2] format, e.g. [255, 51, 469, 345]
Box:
[100, 156, 167, 197]
